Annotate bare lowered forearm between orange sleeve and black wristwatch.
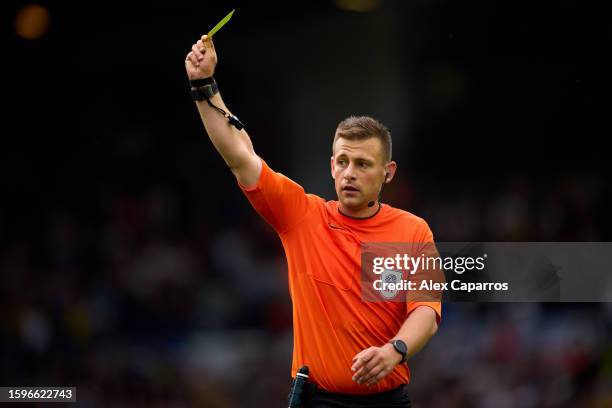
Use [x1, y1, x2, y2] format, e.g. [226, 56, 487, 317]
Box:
[394, 306, 438, 358]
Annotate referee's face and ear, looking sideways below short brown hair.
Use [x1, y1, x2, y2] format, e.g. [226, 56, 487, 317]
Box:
[331, 137, 396, 211]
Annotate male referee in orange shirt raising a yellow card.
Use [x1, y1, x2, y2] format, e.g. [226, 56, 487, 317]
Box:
[185, 38, 441, 407]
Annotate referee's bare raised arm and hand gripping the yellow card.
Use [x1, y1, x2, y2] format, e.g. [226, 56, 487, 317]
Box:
[185, 36, 261, 186]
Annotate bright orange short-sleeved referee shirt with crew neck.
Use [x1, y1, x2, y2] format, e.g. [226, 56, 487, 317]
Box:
[240, 160, 441, 394]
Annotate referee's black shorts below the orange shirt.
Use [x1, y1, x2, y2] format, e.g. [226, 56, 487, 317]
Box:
[303, 384, 410, 408]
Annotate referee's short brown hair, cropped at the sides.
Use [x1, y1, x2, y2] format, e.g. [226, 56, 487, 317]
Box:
[333, 116, 391, 163]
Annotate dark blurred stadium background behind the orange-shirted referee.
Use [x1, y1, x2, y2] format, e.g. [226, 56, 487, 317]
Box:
[0, 0, 612, 407]
